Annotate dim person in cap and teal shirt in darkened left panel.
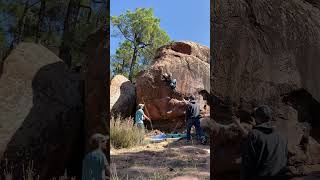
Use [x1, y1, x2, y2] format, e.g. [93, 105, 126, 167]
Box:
[82, 133, 110, 180]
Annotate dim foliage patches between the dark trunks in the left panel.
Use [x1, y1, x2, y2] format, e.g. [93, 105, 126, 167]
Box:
[0, 0, 106, 65]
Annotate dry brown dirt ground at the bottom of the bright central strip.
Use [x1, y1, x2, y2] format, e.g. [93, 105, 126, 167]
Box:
[110, 134, 210, 180]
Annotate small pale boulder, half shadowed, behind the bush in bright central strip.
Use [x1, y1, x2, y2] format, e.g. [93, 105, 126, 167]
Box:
[110, 75, 136, 117]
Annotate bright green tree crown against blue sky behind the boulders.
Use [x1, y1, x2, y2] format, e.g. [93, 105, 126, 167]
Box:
[111, 8, 170, 78]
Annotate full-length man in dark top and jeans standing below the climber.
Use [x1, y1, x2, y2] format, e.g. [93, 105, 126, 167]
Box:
[186, 95, 206, 144]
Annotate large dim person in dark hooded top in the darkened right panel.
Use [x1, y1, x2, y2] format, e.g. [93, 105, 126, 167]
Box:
[234, 106, 288, 180]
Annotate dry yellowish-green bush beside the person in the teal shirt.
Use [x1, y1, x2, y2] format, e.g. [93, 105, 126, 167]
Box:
[110, 117, 144, 149]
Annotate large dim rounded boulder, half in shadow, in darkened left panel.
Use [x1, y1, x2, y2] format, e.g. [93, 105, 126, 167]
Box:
[0, 43, 83, 179]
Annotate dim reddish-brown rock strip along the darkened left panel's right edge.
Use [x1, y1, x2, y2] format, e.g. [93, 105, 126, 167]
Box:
[83, 29, 110, 154]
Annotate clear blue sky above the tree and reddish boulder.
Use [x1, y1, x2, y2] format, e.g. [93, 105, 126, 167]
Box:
[110, 0, 210, 55]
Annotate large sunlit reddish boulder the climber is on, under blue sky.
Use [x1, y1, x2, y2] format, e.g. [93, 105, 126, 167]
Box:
[136, 42, 210, 128]
